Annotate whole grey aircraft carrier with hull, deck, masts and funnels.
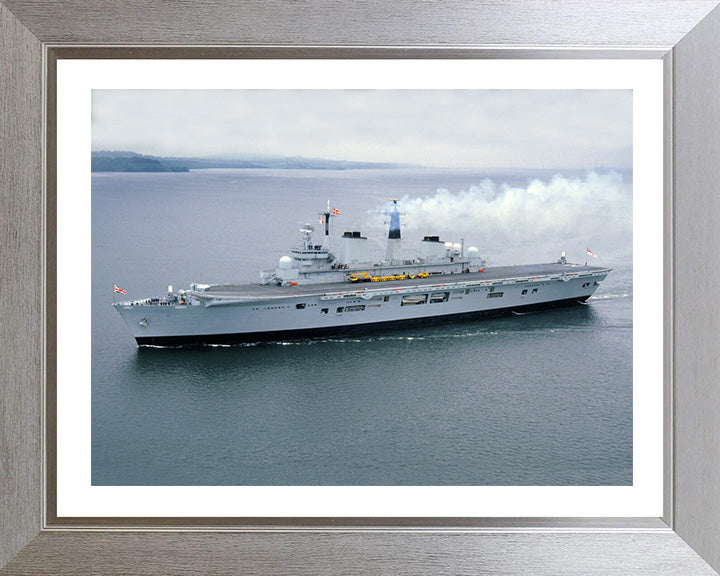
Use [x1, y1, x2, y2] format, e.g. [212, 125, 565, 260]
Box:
[113, 200, 611, 346]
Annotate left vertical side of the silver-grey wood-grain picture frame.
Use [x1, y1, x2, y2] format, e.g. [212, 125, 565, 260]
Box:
[0, 4, 42, 566]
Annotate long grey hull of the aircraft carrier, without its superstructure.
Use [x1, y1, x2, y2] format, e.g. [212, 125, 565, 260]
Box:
[114, 263, 610, 346]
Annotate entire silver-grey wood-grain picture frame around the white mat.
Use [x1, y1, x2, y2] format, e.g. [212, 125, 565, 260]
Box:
[0, 0, 720, 574]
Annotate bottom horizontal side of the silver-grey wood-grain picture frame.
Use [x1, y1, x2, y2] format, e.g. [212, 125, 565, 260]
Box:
[0, 532, 715, 576]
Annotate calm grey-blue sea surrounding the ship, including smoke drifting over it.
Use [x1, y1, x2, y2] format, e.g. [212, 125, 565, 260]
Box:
[92, 169, 633, 485]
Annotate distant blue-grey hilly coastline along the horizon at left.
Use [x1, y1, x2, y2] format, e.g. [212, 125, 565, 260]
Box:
[91, 150, 417, 172]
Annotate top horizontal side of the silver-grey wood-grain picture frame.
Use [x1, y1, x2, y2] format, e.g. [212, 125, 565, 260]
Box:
[4, 0, 717, 49]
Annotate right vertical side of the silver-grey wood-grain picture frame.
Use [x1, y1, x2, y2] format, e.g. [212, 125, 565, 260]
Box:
[673, 1, 720, 569]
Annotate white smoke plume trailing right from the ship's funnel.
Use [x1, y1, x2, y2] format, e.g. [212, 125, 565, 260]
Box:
[371, 172, 632, 263]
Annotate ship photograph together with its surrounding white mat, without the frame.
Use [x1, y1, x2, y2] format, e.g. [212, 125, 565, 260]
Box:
[54, 59, 663, 525]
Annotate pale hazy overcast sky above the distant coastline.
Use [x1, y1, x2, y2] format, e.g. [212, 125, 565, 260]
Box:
[92, 90, 632, 169]
